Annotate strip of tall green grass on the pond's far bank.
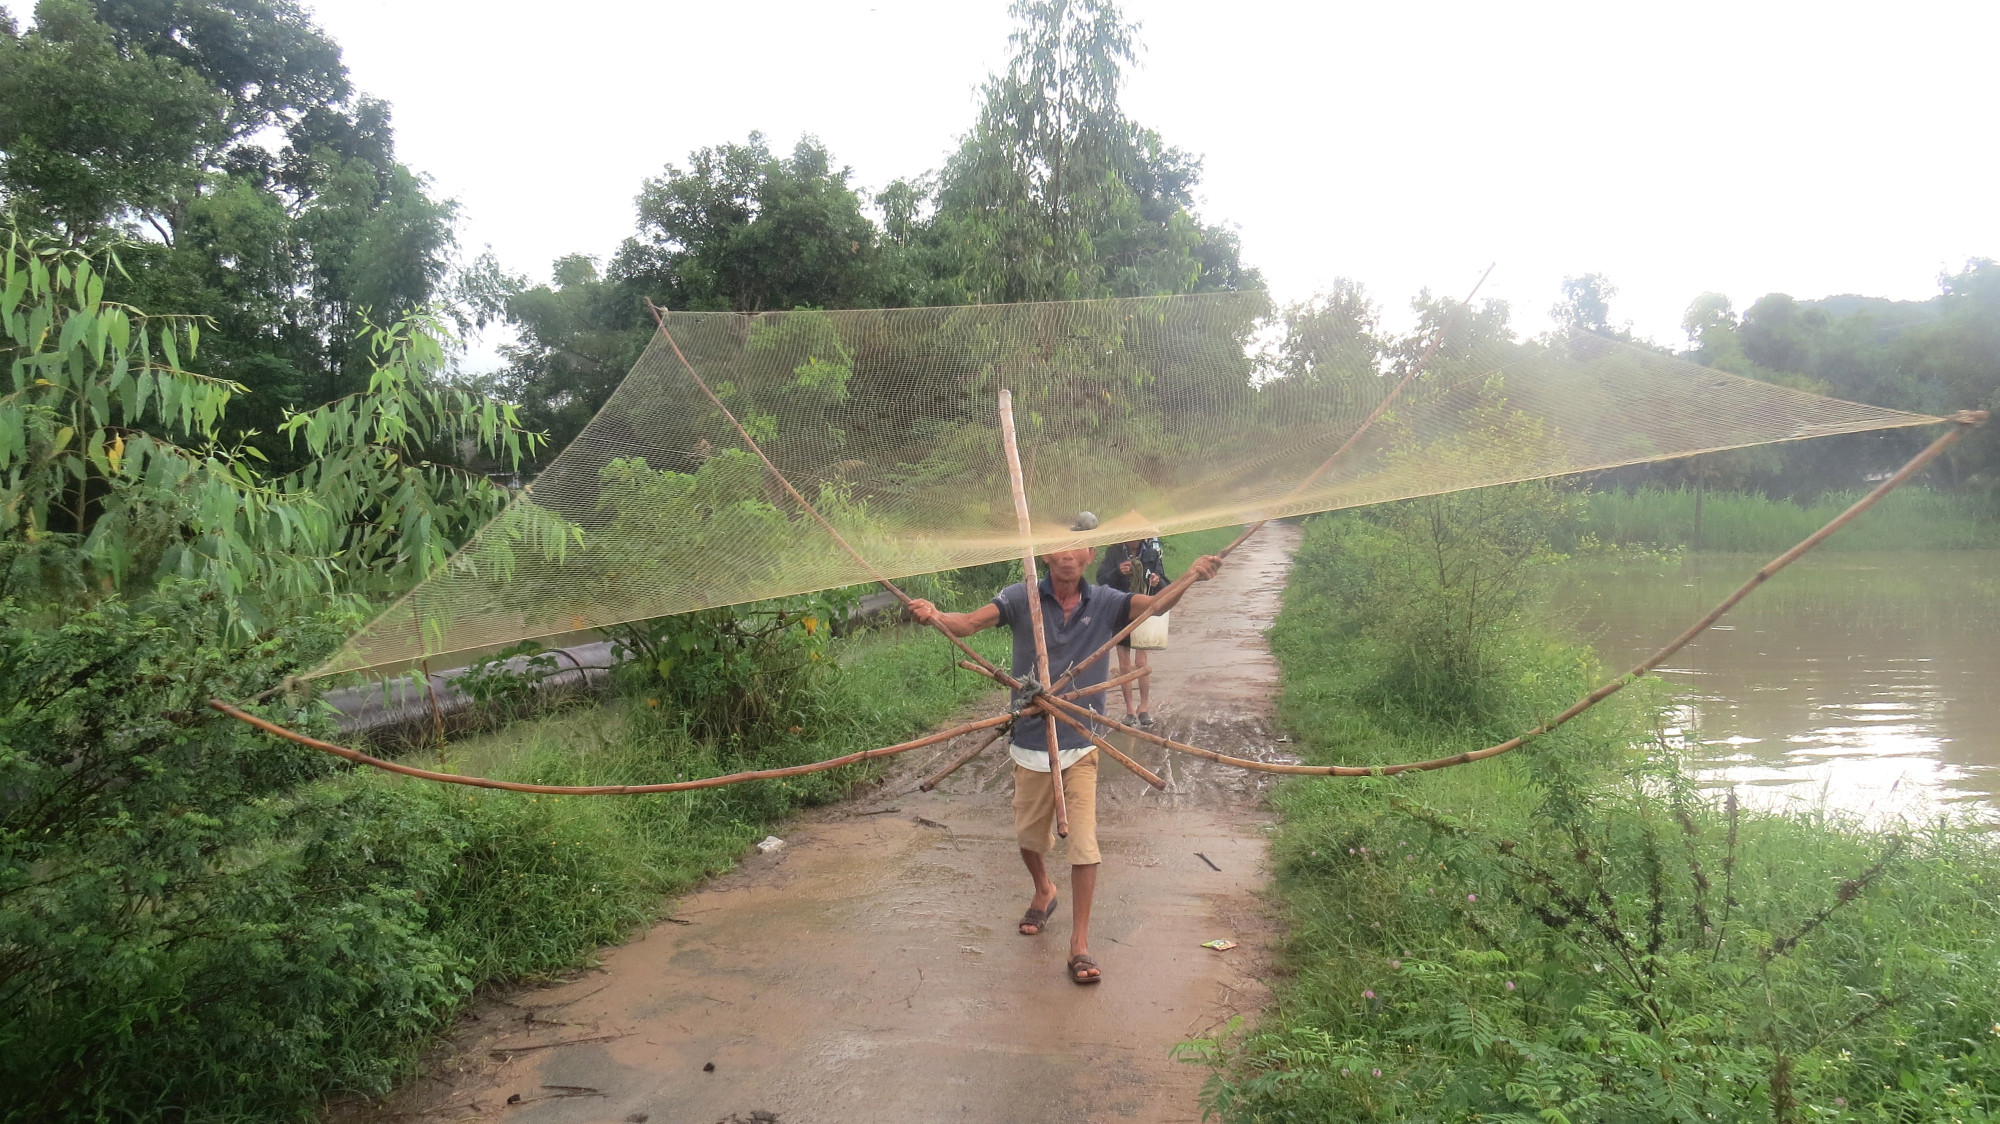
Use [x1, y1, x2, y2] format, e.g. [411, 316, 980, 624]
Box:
[1580, 488, 2000, 554]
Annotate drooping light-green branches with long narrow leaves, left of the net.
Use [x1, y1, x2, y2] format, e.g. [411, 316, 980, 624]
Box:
[0, 234, 562, 630]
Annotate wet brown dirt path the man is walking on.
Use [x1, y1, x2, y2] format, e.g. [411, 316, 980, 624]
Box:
[356, 524, 1298, 1124]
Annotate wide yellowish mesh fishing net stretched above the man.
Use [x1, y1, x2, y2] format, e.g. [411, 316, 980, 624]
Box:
[314, 292, 1936, 674]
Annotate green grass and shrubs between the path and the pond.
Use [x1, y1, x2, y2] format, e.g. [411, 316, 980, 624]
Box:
[1186, 490, 2000, 1124]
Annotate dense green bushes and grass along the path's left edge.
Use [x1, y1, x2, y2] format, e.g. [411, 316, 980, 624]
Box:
[0, 594, 998, 1120]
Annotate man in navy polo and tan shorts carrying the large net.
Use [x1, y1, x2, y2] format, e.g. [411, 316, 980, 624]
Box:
[910, 546, 1222, 984]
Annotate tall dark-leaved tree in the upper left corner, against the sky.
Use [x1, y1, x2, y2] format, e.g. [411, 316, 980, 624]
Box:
[0, 0, 456, 468]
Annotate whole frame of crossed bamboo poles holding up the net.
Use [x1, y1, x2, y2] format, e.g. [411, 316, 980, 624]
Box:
[208, 290, 1986, 796]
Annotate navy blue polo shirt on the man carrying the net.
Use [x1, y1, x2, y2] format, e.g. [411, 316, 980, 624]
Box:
[994, 578, 1132, 760]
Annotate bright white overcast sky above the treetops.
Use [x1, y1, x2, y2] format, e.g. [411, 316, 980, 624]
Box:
[308, 0, 2000, 358]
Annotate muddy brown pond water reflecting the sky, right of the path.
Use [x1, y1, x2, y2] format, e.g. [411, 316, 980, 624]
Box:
[1552, 550, 2000, 820]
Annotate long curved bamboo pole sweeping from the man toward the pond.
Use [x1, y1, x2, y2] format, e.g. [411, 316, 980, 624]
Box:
[1044, 410, 1986, 776]
